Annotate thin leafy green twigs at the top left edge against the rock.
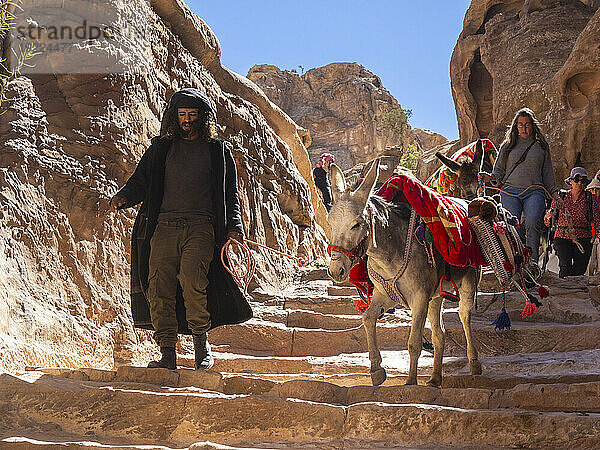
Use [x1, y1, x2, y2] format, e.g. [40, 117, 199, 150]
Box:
[0, 0, 39, 115]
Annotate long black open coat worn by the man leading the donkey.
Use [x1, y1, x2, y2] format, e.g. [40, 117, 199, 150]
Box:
[119, 136, 252, 334]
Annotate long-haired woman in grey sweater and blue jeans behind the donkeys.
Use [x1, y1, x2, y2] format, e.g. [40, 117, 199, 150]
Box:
[483, 108, 562, 263]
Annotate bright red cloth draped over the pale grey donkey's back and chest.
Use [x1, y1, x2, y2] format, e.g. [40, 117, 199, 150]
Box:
[349, 174, 486, 312]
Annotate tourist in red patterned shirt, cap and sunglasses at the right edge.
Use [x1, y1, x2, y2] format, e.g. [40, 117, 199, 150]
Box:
[544, 167, 600, 278]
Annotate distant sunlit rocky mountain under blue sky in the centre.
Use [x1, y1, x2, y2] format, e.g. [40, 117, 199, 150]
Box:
[248, 63, 424, 169]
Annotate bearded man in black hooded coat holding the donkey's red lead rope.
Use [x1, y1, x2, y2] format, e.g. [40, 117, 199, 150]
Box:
[111, 88, 252, 370]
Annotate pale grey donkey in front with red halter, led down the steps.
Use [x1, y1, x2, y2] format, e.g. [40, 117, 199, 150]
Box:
[328, 160, 481, 386]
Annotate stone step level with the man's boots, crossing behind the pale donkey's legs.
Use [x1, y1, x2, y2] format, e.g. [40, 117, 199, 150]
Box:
[209, 320, 600, 356]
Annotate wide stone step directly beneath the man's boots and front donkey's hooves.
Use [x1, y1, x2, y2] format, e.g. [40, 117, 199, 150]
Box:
[36, 362, 600, 395]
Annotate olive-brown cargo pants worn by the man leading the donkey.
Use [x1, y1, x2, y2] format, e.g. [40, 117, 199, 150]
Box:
[148, 217, 215, 347]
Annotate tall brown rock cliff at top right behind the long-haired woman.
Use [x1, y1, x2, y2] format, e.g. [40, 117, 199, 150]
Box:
[450, 0, 600, 179]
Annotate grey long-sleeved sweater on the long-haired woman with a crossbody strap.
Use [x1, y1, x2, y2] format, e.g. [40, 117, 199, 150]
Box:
[492, 136, 558, 194]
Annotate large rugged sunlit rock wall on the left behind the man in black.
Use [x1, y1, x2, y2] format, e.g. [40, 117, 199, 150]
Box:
[0, 0, 325, 370]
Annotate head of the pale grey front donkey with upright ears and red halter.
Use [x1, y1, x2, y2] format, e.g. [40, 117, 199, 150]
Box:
[327, 159, 379, 282]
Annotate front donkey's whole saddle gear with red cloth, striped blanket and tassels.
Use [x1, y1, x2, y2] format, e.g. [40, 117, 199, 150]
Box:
[342, 174, 548, 329]
